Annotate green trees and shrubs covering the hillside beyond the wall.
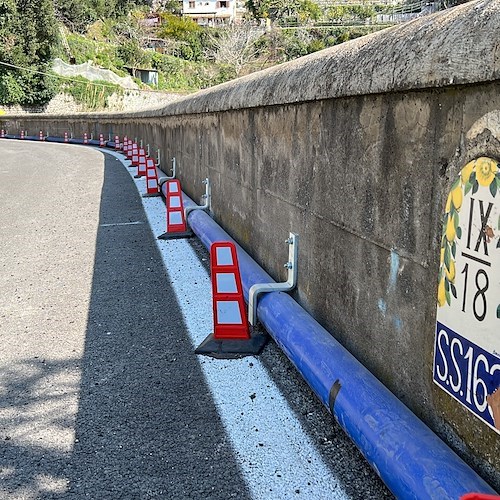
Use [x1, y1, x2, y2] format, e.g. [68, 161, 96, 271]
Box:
[0, 0, 468, 109]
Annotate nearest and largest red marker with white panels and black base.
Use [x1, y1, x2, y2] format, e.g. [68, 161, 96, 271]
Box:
[195, 241, 267, 358]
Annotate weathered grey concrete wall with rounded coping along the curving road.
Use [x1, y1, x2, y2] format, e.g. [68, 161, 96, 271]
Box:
[0, 0, 500, 490]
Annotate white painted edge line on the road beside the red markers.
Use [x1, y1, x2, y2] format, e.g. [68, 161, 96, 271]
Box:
[112, 151, 349, 500]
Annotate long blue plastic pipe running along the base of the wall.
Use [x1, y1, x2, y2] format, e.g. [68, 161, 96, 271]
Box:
[166, 185, 496, 500]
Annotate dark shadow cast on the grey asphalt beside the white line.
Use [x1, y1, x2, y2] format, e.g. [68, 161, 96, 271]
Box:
[0, 156, 249, 499]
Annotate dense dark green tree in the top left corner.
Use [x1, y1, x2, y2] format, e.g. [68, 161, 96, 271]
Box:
[0, 0, 58, 105]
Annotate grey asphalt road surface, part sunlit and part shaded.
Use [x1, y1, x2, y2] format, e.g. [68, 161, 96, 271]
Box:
[0, 140, 390, 499]
